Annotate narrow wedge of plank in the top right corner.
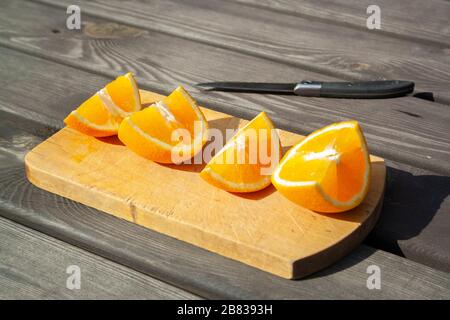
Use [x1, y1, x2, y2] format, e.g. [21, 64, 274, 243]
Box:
[234, 0, 450, 46]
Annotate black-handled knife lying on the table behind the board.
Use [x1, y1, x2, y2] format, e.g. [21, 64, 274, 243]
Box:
[195, 80, 414, 99]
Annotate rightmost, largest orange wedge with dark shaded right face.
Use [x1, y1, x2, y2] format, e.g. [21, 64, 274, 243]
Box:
[272, 121, 371, 213]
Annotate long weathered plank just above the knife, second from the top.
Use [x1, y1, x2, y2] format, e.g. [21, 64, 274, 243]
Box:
[33, 0, 450, 102]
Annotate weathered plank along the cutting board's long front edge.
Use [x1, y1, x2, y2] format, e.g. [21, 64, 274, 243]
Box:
[0, 111, 450, 299]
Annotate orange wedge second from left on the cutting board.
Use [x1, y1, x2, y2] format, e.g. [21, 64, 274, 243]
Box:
[119, 86, 208, 163]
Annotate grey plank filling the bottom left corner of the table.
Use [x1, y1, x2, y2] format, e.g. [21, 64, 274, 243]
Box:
[0, 218, 198, 300]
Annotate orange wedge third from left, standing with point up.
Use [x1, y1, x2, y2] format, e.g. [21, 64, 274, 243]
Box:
[200, 112, 281, 192]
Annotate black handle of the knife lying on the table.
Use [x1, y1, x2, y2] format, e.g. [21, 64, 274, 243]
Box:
[294, 80, 414, 99]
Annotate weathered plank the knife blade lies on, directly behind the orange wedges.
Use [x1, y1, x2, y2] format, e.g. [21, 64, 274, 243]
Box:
[0, 1, 450, 174]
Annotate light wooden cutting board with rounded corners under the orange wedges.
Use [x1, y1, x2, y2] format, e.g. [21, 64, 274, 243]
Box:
[25, 91, 386, 278]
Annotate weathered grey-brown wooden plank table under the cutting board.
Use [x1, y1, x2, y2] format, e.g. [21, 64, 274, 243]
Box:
[0, 0, 450, 299]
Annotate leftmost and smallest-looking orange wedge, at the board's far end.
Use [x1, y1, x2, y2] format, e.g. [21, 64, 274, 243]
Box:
[64, 73, 141, 137]
